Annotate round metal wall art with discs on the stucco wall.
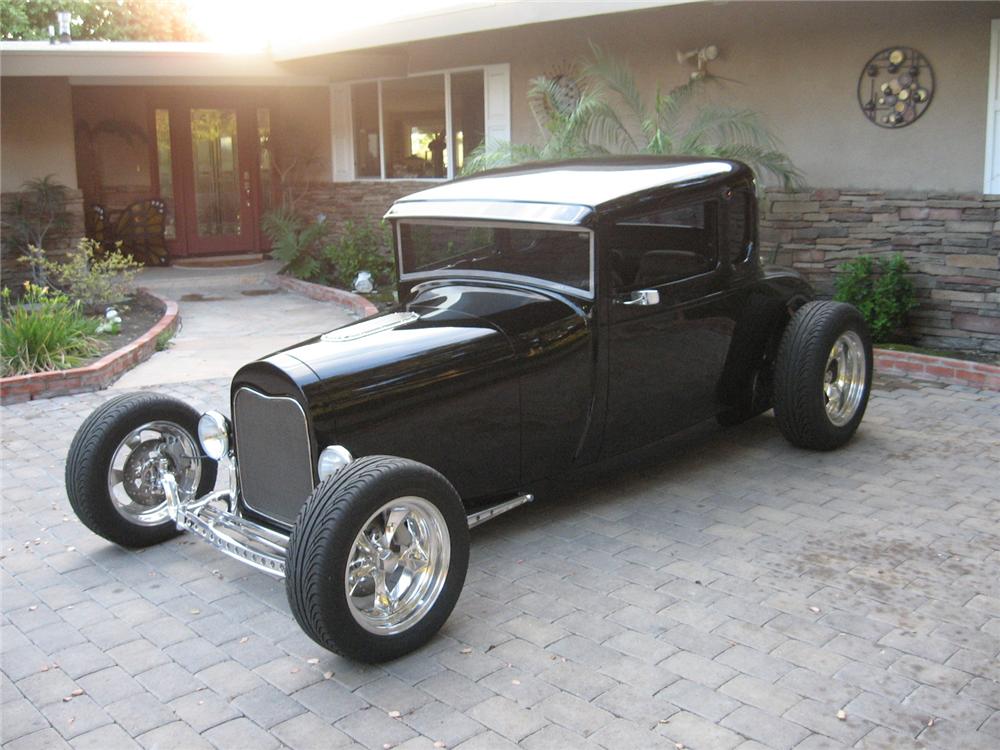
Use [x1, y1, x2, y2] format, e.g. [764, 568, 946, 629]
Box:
[858, 47, 934, 128]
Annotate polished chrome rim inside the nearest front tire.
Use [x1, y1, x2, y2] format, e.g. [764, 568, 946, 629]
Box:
[345, 497, 451, 635]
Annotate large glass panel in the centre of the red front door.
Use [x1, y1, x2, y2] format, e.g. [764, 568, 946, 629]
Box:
[191, 109, 242, 237]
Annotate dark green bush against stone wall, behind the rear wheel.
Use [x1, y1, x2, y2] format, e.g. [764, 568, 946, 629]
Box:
[834, 253, 917, 342]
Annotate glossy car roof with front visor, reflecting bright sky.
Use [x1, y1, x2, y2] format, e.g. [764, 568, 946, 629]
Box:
[386, 157, 749, 224]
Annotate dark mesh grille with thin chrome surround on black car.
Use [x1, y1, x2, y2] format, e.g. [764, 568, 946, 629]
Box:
[233, 386, 314, 526]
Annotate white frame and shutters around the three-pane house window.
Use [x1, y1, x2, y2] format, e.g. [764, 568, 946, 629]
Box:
[330, 64, 510, 184]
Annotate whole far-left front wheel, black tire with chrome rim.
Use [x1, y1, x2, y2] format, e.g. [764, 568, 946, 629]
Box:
[66, 393, 217, 547]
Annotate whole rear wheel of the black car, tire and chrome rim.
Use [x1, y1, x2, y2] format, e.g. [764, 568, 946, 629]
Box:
[774, 301, 872, 450]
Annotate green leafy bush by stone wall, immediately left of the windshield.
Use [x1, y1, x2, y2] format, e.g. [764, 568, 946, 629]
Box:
[322, 221, 395, 289]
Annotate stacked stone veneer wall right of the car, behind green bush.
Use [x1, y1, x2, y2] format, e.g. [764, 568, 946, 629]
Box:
[760, 189, 1000, 352]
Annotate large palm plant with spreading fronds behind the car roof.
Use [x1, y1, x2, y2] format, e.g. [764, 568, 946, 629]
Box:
[465, 44, 801, 188]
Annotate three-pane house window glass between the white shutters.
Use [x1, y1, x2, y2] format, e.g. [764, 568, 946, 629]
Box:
[350, 69, 486, 179]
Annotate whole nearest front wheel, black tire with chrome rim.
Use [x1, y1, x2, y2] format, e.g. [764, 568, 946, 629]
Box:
[285, 456, 469, 662]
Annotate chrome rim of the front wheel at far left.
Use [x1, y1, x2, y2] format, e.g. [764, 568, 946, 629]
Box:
[108, 421, 201, 526]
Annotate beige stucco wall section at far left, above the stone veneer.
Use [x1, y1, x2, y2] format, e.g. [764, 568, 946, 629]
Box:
[0, 78, 77, 193]
